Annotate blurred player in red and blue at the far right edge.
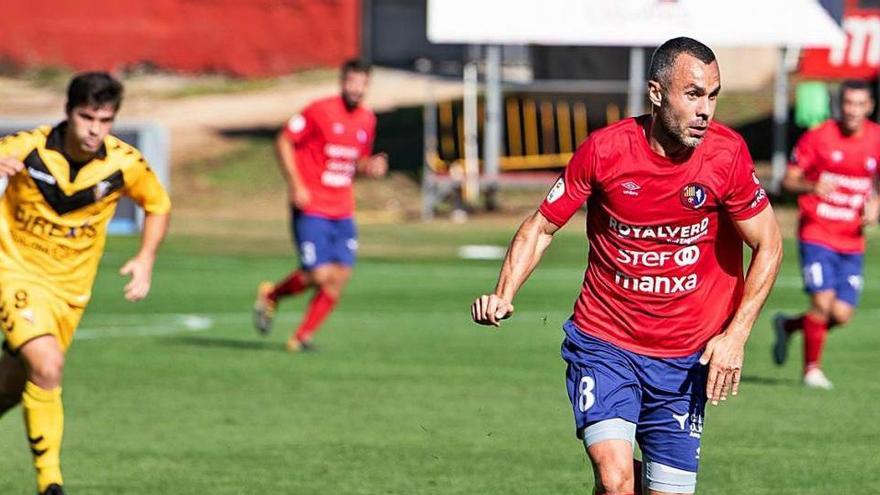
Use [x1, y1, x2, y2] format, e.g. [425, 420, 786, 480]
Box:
[773, 81, 880, 389]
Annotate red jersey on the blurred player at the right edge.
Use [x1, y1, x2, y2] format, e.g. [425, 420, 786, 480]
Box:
[789, 120, 880, 253]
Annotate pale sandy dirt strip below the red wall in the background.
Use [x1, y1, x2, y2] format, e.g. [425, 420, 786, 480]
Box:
[0, 68, 461, 165]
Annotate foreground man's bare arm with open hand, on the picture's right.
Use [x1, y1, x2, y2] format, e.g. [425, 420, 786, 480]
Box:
[700, 206, 782, 405]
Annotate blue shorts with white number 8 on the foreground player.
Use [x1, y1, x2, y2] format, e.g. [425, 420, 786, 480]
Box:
[562, 321, 708, 493]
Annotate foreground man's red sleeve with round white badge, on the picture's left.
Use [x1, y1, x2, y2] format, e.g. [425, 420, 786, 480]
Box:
[539, 139, 596, 227]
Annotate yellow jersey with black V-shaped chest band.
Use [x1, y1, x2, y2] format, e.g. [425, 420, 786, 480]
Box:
[0, 122, 171, 307]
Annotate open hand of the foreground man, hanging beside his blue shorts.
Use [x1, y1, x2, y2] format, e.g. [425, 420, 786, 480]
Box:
[700, 332, 745, 406]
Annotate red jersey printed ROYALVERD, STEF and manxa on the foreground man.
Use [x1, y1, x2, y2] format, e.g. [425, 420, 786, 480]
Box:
[540, 116, 769, 357]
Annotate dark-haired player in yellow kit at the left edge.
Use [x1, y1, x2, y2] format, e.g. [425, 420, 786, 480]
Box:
[0, 72, 171, 494]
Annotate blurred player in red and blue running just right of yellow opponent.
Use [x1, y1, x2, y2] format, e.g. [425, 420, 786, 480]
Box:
[254, 60, 388, 352]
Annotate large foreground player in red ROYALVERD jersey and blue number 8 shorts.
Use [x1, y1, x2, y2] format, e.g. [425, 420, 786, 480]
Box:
[471, 38, 782, 495]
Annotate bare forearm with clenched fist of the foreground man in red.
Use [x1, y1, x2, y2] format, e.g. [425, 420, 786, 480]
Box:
[471, 211, 559, 327]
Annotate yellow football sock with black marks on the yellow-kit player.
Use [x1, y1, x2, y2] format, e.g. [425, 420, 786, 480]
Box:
[22, 381, 64, 492]
